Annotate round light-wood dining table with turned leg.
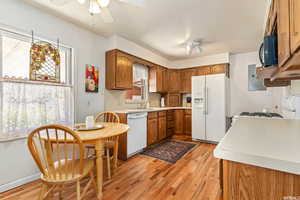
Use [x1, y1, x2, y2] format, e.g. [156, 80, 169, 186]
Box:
[75, 122, 129, 199]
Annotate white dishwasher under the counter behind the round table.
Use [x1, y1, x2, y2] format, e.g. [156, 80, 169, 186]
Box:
[127, 112, 148, 157]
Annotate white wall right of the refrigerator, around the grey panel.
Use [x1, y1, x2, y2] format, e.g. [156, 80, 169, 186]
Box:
[230, 52, 282, 115]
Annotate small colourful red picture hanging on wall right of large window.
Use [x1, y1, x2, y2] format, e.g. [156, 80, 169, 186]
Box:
[85, 65, 99, 92]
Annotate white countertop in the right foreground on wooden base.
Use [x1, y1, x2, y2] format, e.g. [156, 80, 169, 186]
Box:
[214, 118, 300, 175]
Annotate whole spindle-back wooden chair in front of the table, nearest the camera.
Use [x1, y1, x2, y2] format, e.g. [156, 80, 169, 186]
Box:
[28, 125, 97, 200]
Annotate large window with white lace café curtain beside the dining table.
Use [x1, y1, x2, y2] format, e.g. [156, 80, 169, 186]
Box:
[0, 31, 74, 140]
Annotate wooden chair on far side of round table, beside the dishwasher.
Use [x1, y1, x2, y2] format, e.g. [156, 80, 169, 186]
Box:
[87, 112, 120, 179]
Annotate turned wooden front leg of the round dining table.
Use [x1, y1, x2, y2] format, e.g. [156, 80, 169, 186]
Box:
[95, 140, 104, 199]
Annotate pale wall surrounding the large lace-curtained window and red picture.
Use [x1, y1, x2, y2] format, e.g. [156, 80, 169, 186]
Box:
[0, 0, 108, 192]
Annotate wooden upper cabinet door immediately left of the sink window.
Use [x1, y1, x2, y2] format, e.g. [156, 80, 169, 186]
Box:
[115, 54, 133, 89]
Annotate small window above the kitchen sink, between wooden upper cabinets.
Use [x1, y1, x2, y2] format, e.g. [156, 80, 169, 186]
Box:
[125, 63, 149, 103]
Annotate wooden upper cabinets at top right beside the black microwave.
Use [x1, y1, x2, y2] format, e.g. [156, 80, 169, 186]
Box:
[257, 0, 300, 82]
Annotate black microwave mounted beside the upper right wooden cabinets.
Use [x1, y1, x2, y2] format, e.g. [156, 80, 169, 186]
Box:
[259, 34, 278, 67]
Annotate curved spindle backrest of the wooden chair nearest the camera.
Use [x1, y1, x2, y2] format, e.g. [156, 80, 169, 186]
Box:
[28, 125, 84, 181]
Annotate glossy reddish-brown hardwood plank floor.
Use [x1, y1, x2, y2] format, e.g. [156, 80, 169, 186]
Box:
[0, 143, 221, 200]
